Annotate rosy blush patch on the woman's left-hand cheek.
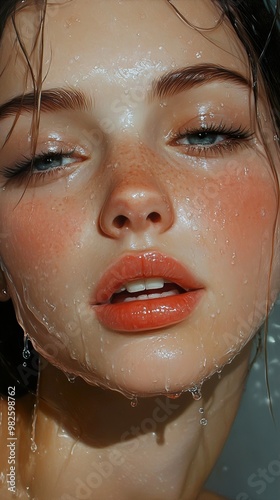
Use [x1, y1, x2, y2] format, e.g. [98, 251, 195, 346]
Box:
[7, 199, 82, 264]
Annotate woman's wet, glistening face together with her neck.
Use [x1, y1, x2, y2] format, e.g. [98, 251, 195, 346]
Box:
[0, 0, 280, 500]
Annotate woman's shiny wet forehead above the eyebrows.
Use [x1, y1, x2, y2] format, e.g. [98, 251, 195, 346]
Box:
[1, 0, 248, 102]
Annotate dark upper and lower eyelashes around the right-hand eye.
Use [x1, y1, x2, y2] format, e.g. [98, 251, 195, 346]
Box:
[170, 123, 254, 156]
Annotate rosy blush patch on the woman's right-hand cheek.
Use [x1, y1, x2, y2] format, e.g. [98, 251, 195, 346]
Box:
[200, 171, 277, 260]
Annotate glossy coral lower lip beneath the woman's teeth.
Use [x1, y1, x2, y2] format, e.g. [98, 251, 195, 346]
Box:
[94, 289, 203, 332]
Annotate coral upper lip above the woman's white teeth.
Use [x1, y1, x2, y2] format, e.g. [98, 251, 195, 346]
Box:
[92, 251, 204, 305]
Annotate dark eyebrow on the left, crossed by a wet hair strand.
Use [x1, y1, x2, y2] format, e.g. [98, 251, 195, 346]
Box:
[0, 87, 92, 120]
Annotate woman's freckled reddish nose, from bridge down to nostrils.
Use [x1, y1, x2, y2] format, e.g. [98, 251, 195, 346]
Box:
[100, 144, 174, 238]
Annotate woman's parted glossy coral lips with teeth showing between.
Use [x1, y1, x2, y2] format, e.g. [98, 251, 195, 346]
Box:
[91, 252, 203, 332]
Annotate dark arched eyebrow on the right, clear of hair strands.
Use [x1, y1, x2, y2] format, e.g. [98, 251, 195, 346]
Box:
[150, 64, 252, 99]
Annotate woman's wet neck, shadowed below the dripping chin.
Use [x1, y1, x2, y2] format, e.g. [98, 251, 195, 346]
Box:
[19, 346, 250, 500]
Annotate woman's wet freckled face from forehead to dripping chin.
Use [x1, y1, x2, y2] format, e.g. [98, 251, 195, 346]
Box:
[0, 0, 279, 395]
